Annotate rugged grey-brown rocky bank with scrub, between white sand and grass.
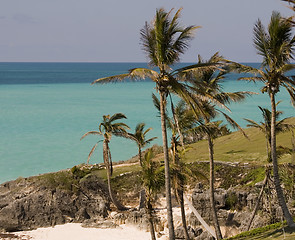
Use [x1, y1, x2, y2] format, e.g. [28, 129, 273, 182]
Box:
[0, 162, 295, 239]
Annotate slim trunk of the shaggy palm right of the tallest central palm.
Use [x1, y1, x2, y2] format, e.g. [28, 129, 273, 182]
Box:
[207, 134, 222, 239]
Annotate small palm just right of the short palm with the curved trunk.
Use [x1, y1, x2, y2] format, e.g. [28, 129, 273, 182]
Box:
[127, 123, 157, 166]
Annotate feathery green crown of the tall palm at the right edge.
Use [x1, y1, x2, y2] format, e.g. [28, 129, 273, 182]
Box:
[233, 12, 295, 100]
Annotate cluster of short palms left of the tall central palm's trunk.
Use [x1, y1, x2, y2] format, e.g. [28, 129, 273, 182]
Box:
[81, 113, 164, 239]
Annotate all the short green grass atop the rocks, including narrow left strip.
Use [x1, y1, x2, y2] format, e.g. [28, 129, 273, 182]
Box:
[85, 118, 295, 184]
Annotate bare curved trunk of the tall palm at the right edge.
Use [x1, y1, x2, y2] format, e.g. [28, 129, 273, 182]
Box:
[269, 92, 295, 227]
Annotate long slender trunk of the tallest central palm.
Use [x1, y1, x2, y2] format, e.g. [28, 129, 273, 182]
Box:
[160, 90, 175, 240]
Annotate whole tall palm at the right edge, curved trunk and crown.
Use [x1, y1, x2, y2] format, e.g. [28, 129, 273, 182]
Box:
[233, 12, 295, 227]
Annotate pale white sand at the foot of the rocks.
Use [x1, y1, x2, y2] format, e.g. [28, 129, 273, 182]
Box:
[14, 223, 165, 240]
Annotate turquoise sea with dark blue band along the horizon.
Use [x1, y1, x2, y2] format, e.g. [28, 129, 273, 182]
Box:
[0, 63, 294, 183]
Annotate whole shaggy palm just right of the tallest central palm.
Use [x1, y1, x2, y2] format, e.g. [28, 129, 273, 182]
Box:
[188, 53, 252, 239]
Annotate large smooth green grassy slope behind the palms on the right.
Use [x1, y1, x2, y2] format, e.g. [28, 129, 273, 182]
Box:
[186, 118, 295, 165]
